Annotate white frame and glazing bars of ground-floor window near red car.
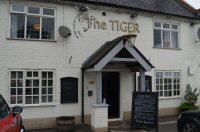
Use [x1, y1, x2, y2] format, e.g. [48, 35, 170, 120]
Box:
[8, 69, 56, 107]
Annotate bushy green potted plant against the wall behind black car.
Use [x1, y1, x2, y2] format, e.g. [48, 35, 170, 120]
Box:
[180, 84, 199, 111]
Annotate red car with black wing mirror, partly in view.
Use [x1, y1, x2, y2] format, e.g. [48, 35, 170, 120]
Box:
[0, 94, 25, 132]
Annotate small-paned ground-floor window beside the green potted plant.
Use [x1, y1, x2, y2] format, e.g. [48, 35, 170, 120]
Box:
[155, 71, 181, 97]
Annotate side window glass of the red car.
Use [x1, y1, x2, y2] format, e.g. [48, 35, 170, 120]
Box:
[0, 95, 10, 120]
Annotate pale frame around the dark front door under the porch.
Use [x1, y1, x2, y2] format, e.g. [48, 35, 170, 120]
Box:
[102, 69, 123, 121]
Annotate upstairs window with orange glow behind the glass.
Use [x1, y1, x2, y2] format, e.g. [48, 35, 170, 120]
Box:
[10, 4, 55, 40]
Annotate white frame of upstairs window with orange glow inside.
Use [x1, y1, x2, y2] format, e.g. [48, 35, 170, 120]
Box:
[9, 4, 56, 41]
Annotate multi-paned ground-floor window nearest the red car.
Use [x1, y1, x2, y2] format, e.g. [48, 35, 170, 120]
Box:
[10, 70, 54, 105]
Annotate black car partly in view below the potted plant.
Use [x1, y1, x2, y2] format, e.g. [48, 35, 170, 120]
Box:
[177, 110, 200, 132]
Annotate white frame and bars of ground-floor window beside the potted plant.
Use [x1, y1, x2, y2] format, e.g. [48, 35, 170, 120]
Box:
[154, 70, 182, 99]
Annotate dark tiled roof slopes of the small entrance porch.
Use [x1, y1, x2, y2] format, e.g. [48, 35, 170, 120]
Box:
[82, 35, 154, 69]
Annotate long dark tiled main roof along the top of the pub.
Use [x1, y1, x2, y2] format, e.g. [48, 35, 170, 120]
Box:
[67, 0, 199, 18]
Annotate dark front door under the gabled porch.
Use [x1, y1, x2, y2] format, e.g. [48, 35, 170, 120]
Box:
[102, 72, 120, 119]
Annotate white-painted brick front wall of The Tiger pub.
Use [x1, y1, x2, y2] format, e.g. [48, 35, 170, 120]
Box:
[0, 0, 200, 119]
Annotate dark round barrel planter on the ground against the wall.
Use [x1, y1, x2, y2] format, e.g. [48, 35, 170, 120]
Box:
[56, 116, 75, 132]
